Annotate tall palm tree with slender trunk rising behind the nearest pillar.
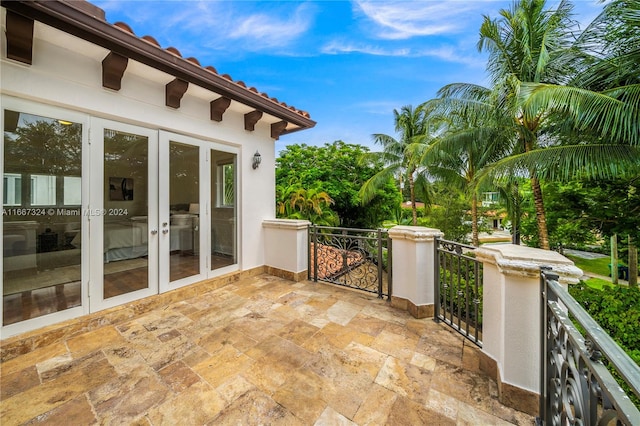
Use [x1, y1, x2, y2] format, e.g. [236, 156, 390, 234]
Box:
[468, 0, 578, 249]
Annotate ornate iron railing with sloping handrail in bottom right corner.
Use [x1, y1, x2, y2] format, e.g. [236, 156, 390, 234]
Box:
[538, 271, 640, 426]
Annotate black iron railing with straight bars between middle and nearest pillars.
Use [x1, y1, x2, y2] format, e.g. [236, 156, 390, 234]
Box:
[434, 239, 482, 347]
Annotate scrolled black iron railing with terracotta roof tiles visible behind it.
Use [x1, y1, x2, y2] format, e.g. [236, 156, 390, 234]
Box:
[308, 225, 391, 300]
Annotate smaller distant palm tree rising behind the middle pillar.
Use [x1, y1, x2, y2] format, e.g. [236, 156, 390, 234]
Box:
[358, 105, 427, 226]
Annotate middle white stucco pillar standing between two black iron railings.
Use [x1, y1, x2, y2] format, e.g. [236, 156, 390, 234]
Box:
[389, 226, 444, 318]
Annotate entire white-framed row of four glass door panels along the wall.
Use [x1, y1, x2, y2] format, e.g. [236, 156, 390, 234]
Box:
[0, 100, 240, 335]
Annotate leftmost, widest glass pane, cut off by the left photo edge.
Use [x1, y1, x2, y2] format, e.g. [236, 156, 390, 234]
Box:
[2, 109, 82, 325]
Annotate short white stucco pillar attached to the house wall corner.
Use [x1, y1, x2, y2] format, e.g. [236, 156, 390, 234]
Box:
[262, 219, 311, 281]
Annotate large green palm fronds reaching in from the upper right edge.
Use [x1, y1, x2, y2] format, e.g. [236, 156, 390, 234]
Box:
[520, 0, 640, 175]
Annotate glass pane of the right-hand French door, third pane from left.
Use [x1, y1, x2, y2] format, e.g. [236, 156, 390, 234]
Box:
[169, 140, 201, 282]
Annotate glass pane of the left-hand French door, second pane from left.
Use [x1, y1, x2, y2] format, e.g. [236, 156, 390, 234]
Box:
[102, 128, 150, 300]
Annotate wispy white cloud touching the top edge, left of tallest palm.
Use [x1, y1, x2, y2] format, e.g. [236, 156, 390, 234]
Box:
[355, 0, 498, 39]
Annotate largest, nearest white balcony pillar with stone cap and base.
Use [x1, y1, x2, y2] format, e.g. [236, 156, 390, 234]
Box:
[476, 244, 582, 415]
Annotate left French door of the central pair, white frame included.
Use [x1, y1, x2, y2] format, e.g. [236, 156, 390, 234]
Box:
[85, 118, 159, 312]
